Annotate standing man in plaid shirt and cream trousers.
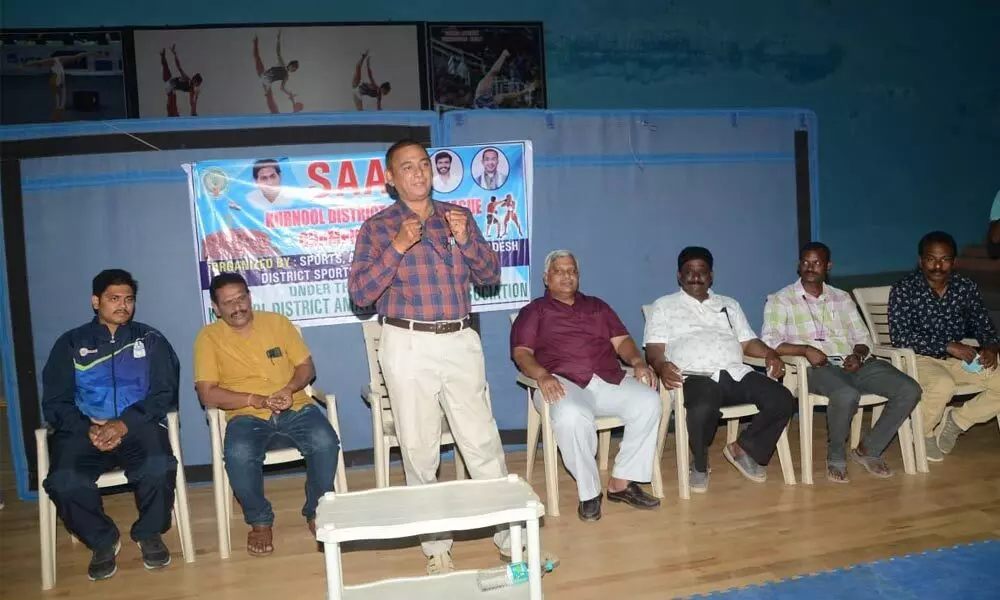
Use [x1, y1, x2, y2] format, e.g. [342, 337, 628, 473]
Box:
[348, 140, 510, 575]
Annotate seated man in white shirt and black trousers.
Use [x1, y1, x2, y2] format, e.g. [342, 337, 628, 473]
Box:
[644, 246, 798, 493]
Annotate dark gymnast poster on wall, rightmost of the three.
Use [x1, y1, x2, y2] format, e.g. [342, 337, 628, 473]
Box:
[427, 23, 547, 111]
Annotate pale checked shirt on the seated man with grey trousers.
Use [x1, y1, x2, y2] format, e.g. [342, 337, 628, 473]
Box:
[760, 279, 872, 356]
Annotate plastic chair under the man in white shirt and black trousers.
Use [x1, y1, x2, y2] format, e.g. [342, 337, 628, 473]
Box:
[642, 304, 795, 500]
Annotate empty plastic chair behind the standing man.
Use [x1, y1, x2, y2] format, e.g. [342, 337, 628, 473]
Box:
[361, 320, 492, 488]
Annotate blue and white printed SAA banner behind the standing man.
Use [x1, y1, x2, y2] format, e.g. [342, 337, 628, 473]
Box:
[184, 142, 533, 327]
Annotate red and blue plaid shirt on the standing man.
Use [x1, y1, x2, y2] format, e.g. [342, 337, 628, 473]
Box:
[348, 200, 500, 321]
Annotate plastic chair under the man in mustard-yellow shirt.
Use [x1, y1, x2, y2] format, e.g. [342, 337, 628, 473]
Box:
[205, 385, 347, 559]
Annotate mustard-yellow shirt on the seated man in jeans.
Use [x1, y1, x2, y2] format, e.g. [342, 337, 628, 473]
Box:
[194, 310, 312, 420]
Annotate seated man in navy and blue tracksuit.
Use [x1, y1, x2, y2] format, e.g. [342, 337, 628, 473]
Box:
[42, 269, 180, 581]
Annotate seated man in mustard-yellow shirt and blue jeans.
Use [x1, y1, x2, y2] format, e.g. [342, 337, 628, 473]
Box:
[194, 273, 340, 556]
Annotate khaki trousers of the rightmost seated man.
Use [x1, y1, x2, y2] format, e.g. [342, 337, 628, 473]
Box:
[917, 354, 1000, 438]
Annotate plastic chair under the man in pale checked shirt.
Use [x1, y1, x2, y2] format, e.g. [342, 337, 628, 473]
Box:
[781, 356, 917, 485]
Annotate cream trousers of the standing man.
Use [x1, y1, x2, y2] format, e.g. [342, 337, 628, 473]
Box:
[378, 325, 510, 556]
